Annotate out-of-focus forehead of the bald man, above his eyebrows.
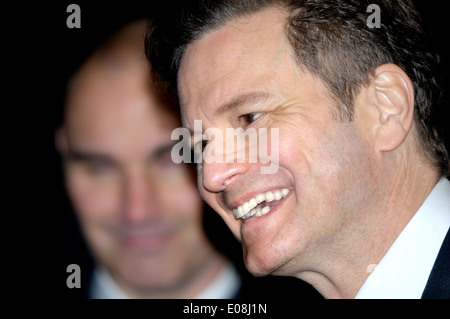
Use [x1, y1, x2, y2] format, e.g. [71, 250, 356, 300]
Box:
[65, 56, 180, 149]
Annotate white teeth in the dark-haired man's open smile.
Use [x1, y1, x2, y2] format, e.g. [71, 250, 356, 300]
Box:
[233, 188, 289, 219]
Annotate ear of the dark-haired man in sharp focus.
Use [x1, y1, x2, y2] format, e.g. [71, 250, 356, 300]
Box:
[370, 64, 414, 151]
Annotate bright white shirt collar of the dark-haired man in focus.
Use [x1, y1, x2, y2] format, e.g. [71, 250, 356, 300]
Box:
[355, 178, 450, 299]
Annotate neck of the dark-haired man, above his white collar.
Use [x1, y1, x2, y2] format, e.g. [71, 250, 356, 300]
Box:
[297, 161, 439, 298]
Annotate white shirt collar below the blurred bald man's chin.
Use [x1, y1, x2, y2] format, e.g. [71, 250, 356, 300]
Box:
[89, 263, 241, 299]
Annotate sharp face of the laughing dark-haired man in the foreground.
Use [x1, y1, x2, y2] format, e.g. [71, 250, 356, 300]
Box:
[179, 8, 375, 275]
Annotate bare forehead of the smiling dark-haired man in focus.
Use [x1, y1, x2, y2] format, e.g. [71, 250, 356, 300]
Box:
[178, 7, 288, 127]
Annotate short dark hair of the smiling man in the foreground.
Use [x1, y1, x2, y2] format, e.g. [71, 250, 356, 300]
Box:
[146, 0, 450, 176]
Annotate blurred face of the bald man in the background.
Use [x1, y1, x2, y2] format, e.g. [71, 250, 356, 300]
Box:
[60, 48, 211, 291]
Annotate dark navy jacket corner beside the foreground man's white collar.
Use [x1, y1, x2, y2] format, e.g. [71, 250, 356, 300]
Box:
[422, 230, 450, 299]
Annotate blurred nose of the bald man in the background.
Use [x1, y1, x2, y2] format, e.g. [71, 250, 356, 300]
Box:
[123, 174, 158, 223]
